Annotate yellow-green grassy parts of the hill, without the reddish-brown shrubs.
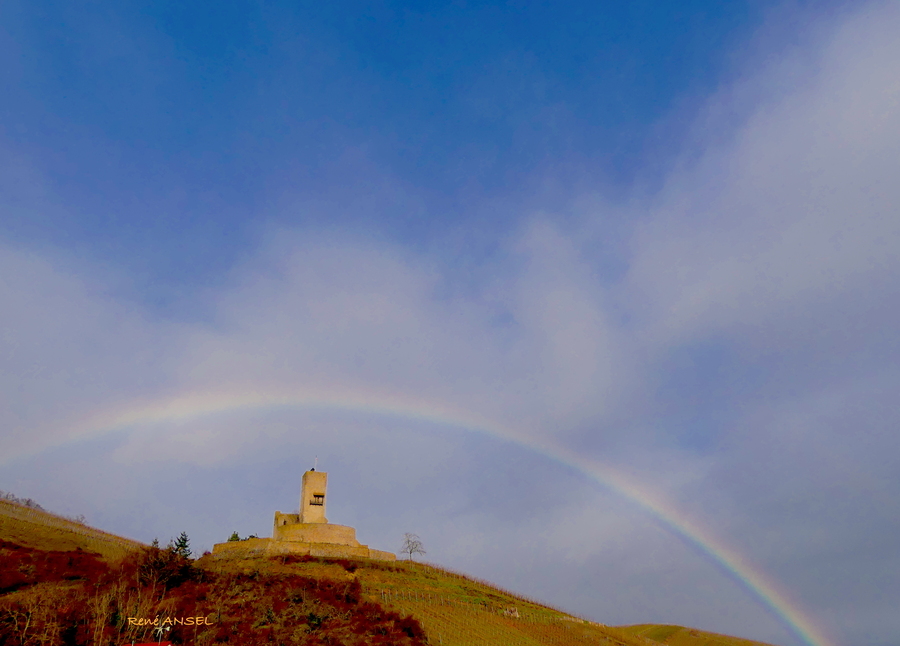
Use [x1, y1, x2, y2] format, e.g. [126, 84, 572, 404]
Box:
[0, 508, 772, 646]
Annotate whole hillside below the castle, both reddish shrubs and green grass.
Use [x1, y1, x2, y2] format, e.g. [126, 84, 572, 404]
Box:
[0, 503, 780, 646]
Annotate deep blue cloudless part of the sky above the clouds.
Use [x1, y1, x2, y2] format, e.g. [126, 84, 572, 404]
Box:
[3, 2, 780, 301]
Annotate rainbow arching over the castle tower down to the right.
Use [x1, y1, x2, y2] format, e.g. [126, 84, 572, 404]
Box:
[7, 386, 832, 646]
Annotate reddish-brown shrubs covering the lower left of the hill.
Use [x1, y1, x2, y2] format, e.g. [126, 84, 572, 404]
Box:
[0, 542, 426, 646]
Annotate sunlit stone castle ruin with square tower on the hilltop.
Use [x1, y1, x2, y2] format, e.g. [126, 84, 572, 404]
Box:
[213, 469, 397, 561]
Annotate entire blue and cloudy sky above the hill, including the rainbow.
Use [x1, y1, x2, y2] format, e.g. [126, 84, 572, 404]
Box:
[0, 0, 900, 646]
